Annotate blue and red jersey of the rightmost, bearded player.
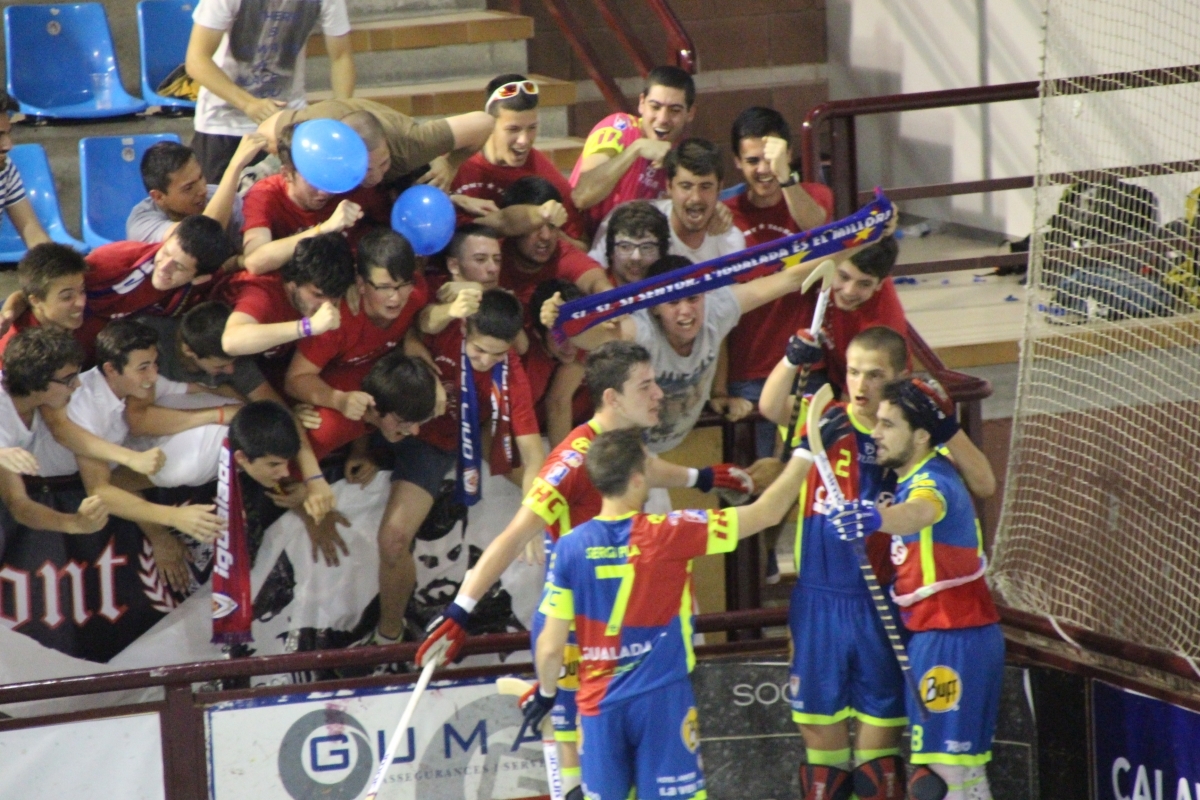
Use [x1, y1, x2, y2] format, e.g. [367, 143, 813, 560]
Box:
[892, 453, 1000, 631]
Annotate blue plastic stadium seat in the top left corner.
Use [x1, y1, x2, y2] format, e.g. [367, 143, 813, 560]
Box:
[4, 2, 146, 120]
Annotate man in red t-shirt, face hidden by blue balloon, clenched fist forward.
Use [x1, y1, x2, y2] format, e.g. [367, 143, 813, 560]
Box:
[241, 125, 391, 275]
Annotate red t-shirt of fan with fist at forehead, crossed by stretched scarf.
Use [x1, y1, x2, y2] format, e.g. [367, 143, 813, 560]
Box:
[725, 189, 833, 381]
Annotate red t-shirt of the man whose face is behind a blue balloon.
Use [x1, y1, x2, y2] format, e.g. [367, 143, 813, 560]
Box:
[241, 174, 391, 247]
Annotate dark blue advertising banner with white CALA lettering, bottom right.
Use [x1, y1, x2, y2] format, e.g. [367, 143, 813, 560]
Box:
[1092, 680, 1200, 800]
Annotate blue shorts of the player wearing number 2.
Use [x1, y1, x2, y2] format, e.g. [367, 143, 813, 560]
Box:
[787, 584, 908, 728]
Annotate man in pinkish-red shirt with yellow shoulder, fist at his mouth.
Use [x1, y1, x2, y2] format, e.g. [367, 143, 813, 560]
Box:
[571, 66, 696, 228]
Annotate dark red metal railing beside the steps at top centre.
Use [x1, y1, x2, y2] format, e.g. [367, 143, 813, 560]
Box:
[532, 0, 697, 113]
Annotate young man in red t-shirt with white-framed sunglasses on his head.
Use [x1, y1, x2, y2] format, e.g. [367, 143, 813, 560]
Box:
[450, 74, 587, 241]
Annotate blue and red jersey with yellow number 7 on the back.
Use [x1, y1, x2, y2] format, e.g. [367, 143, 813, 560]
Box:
[540, 509, 738, 716]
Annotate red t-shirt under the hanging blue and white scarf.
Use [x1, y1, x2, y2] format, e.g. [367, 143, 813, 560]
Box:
[416, 323, 540, 452]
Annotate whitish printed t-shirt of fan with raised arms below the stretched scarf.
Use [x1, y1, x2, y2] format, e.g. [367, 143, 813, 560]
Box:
[632, 287, 742, 453]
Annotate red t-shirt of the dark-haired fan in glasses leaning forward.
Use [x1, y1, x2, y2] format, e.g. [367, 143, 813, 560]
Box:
[296, 272, 430, 391]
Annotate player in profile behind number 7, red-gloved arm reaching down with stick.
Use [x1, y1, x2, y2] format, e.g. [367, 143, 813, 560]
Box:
[416, 342, 752, 792]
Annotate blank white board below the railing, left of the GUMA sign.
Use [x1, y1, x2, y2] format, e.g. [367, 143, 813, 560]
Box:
[0, 698, 164, 800]
